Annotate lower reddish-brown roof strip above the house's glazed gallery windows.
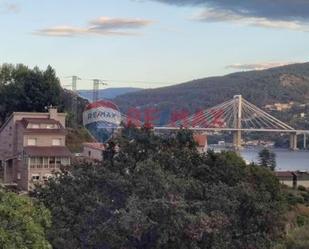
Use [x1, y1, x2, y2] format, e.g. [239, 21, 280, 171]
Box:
[24, 146, 72, 157]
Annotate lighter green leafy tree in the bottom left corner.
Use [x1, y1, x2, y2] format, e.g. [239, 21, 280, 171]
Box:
[0, 190, 51, 249]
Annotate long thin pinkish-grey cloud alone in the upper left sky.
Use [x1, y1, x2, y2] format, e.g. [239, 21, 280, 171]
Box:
[34, 17, 153, 37]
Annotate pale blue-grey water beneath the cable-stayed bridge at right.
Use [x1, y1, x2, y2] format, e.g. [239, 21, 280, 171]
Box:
[241, 149, 309, 171]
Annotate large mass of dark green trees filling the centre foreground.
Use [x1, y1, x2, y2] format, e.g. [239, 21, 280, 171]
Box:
[34, 129, 283, 249]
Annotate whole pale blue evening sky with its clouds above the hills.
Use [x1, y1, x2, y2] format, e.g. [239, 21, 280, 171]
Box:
[0, 0, 309, 89]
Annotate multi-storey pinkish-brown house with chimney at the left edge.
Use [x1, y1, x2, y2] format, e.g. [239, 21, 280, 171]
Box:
[0, 107, 71, 191]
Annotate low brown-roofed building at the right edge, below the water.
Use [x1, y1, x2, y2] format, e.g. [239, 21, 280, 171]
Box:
[276, 171, 309, 188]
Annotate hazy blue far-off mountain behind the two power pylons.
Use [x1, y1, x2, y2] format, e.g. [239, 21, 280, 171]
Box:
[78, 87, 142, 101]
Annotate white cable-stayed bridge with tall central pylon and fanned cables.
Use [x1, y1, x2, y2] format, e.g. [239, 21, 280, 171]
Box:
[148, 95, 309, 150]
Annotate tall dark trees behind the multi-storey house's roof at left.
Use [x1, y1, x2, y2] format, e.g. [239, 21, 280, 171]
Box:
[0, 64, 62, 122]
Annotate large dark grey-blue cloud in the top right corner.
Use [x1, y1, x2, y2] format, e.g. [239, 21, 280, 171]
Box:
[152, 0, 309, 31]
